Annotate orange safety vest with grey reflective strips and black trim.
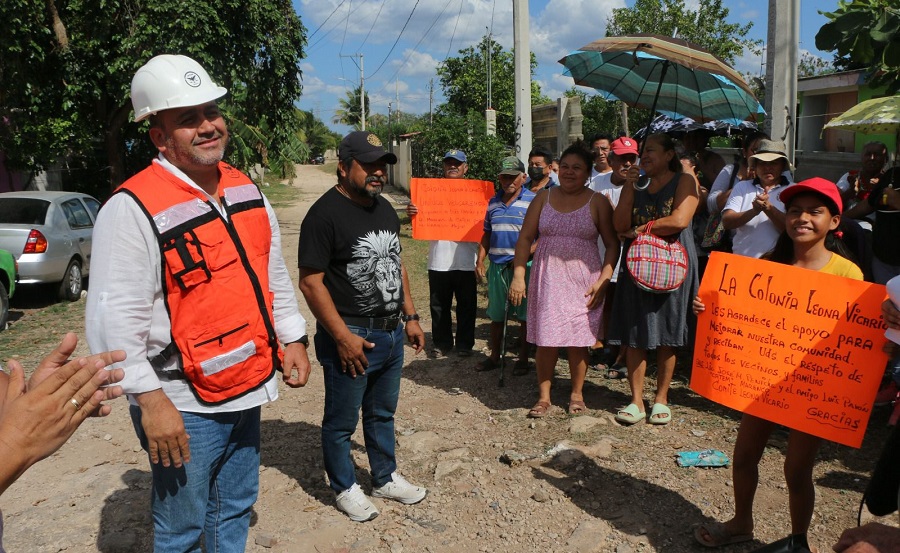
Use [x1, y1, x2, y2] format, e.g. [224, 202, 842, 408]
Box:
[116, 162, 283, 404]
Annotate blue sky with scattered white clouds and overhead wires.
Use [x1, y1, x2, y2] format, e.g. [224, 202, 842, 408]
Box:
[293, 0, 837, 133]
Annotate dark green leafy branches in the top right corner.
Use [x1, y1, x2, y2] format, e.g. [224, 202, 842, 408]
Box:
[816, 0, 900, 95]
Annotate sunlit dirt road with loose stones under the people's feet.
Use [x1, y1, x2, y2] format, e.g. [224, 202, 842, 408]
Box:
[0, 166, 889, 553]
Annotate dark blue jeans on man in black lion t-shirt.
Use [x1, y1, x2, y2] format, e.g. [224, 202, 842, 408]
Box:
[315, 325, 404, 493]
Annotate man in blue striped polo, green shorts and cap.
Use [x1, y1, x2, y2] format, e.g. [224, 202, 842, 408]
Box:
[475, 156, 535, 374]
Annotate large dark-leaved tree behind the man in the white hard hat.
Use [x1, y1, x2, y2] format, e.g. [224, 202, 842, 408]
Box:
[0, 0, 306, 192]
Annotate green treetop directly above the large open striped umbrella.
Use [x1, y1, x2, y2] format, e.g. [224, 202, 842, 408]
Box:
[606, 0, 762, 64]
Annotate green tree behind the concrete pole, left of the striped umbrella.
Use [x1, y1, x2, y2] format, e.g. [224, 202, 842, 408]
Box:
[437, 36, 550, 144]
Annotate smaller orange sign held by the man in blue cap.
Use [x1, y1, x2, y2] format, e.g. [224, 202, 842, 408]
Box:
[409, 179, 494, 242]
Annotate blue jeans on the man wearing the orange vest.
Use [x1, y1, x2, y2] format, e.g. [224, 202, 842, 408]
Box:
[131, 405, 260, 553]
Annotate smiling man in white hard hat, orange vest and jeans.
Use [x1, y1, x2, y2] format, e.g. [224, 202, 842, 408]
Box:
[85, 55, 310, 553]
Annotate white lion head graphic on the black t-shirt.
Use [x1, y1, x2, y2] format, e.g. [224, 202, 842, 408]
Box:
[347, 230, 403, 314]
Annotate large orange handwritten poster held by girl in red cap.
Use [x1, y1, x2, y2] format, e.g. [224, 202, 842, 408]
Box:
[691, 253, 887, 447]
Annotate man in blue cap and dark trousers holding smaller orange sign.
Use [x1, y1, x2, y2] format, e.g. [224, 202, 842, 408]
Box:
[406, 150, 478, 357]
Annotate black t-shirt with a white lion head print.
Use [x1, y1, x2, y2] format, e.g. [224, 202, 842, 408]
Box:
[297, 188, 403, 317]
